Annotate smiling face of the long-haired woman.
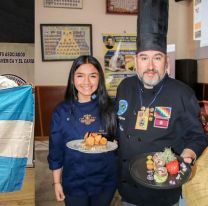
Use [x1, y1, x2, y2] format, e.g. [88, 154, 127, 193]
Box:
[74, 63, 99, 102]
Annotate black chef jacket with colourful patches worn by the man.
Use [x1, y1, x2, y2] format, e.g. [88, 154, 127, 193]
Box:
[116, 75, 207, 206]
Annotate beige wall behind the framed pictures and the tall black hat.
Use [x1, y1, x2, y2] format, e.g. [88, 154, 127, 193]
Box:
[35, 0, 194, 85]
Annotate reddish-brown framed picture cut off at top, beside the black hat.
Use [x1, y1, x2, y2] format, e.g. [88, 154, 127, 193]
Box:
[106, 0, 138, 15]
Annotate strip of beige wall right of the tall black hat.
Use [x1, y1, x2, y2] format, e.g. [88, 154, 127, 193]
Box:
[168, 0, 195, 59]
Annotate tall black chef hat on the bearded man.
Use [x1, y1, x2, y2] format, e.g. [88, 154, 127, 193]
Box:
[137, 0, 169, 54]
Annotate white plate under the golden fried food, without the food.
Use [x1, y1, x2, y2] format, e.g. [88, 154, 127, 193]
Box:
[66, 139, 118, 153]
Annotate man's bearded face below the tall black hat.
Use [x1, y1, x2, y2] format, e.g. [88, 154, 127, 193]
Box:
[136, 50, 167, 88]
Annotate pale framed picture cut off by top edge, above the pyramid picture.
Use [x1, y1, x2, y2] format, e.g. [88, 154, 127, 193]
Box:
[43, 0, 83, 9]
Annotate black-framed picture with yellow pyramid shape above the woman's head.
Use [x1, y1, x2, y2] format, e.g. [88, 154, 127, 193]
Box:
[40, 24, 92, 61]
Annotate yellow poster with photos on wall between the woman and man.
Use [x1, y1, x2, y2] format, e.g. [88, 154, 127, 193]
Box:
[103, 34, 136, 97]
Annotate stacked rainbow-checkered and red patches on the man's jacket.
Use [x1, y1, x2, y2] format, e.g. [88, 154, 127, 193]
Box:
[154, 107, 172, 129]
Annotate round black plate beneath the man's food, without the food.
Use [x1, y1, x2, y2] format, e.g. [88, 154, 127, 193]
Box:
[129, 153, 191, 189]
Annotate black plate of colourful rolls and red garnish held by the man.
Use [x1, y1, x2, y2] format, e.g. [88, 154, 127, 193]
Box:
[130, 148, 191, 189]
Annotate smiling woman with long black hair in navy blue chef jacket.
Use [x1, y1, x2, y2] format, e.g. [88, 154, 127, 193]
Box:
[48, 56, 117, 206]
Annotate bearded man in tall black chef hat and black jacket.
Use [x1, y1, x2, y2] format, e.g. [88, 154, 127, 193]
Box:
[116, 0, 207, 206]
